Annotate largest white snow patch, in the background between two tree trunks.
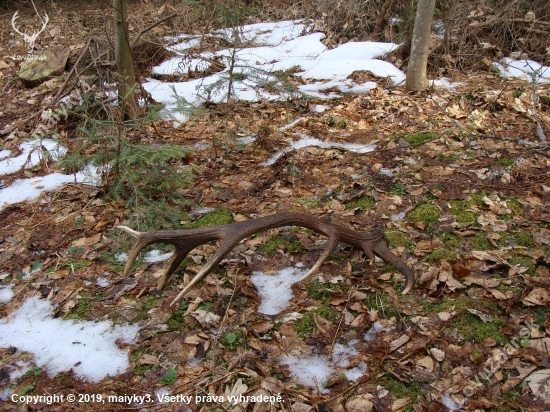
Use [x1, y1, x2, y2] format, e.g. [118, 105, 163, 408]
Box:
[143, 20, 405, 118]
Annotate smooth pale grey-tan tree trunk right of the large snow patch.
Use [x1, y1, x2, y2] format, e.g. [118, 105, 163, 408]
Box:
[405, 0, 435, 91]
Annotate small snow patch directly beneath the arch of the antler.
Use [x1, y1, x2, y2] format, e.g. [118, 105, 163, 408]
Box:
[250, 267, 307, 315]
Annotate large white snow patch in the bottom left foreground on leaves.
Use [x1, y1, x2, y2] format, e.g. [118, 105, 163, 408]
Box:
[0, 296, 139, 382]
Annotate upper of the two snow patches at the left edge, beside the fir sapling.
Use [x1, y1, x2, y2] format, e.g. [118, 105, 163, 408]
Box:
[0, 139, 67, 176]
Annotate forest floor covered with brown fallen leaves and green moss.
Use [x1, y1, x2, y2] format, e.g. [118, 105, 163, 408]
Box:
[0, 1, 550, 412]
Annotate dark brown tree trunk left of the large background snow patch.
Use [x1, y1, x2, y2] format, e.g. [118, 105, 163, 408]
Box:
[113, 0, 138, 119]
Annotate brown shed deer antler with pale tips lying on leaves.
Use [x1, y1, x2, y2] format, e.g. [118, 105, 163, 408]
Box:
[117, 212, 415, 306]
